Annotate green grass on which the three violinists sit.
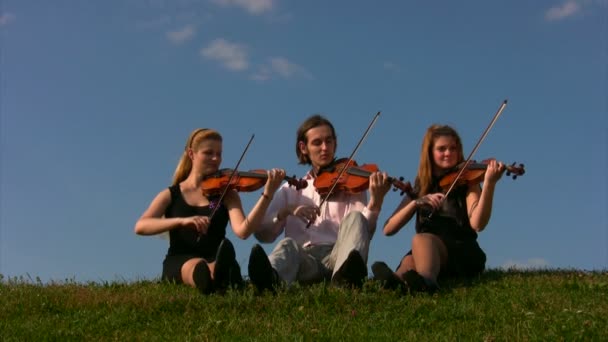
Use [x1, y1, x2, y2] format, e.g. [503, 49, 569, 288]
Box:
[0, 270, 608, 341]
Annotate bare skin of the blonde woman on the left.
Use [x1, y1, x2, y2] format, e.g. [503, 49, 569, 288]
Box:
[135, 139, 285, 287]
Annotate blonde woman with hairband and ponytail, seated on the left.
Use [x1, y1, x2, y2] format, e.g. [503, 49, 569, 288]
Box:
[135, 129, 285, 294]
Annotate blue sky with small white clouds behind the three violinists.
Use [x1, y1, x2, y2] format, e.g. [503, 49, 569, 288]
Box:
[0, 0, 608, 281]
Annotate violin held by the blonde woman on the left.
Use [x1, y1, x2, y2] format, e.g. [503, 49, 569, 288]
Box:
[201, 169, 308, 196]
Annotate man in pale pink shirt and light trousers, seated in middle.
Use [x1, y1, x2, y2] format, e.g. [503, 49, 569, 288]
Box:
[249, 115, 391, 291]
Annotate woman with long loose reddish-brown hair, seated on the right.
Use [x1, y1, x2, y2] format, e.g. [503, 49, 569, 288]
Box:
[372, 125, 505, 293]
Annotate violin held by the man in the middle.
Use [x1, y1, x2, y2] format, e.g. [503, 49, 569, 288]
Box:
[313, 158, 412, 196]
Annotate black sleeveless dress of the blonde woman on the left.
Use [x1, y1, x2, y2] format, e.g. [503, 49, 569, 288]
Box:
[165, 184, 228, 260]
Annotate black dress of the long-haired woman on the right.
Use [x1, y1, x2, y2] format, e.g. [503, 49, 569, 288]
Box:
[416, 179, 477, 241]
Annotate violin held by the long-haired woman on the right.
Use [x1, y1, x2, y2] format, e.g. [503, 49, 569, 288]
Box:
[439, 159, 526, 191]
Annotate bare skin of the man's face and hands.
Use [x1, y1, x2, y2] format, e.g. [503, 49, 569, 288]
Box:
[278, 125, 391, 230]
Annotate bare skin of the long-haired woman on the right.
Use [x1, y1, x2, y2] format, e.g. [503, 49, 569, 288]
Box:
[384, 136, 505, 281]
